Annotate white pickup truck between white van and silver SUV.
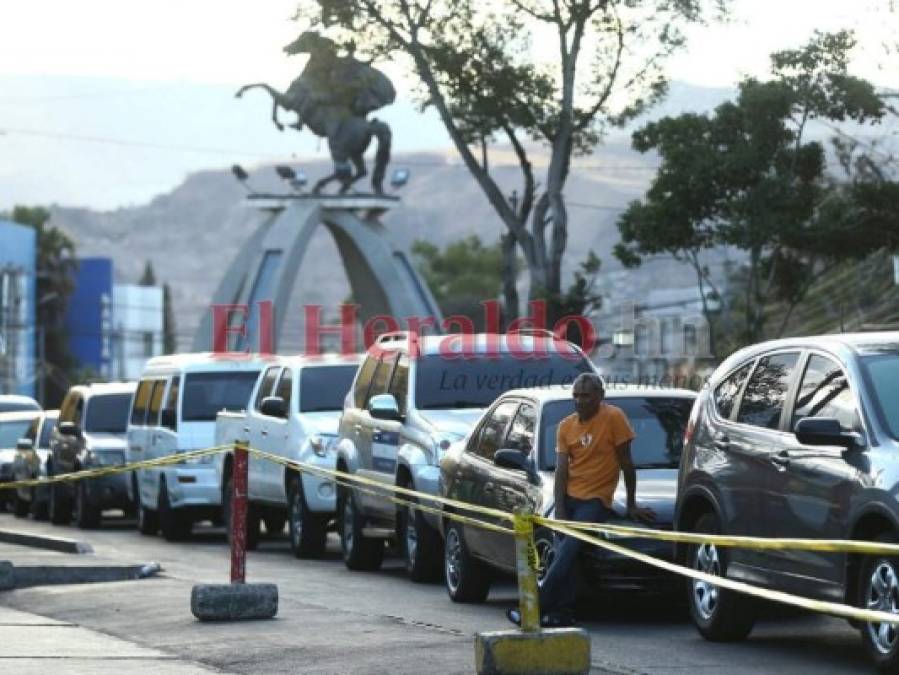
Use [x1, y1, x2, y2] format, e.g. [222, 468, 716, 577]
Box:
[215, 356, 360, 558]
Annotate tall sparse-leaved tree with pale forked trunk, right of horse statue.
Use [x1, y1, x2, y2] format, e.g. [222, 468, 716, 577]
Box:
[298, 0, 726, 322]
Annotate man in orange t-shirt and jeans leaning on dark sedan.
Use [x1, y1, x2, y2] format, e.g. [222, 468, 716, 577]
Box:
[508, 373, 655, 627]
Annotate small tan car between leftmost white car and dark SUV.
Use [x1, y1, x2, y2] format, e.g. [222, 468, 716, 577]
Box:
[13, 410, 59, 520]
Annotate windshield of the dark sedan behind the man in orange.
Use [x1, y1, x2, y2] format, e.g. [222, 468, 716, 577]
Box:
[540, 396, 693, 471]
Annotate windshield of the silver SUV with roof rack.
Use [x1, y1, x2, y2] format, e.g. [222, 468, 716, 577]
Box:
[415, 353, 595, 410]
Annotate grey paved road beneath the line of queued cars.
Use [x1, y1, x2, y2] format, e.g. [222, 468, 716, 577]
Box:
[0, 514, 884, 675]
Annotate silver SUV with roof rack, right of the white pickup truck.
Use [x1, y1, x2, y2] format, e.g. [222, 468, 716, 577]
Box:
[337, 331, 595, 581]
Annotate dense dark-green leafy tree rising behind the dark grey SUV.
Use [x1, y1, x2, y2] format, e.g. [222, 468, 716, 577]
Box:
[615, 31, 884, 352]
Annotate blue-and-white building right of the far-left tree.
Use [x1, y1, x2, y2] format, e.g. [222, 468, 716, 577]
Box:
[66, 258, 163, 380]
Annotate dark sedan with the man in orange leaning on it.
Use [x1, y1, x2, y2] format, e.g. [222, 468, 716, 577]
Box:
[440, 385, 696, 602]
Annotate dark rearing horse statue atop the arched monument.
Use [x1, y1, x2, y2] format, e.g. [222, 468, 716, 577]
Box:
[236, 31, 396, 194]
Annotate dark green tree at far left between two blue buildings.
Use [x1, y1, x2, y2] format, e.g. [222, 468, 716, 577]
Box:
[3, 206, 78, 408]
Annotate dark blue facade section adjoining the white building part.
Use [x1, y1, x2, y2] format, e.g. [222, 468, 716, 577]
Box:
[66, 258, 113, 378]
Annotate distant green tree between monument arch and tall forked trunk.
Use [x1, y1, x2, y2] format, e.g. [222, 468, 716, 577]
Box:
[412, 234, 503, 331]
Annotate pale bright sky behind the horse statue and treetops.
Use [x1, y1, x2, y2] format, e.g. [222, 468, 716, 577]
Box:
[0, 0, 899, 210]
